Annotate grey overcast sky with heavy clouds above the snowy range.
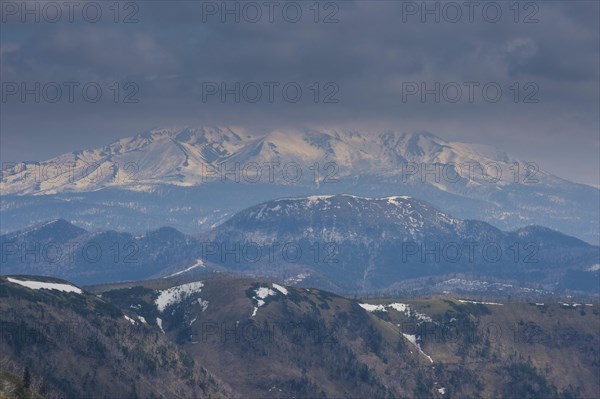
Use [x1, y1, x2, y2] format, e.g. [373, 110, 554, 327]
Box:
[0, 1, 600, 186]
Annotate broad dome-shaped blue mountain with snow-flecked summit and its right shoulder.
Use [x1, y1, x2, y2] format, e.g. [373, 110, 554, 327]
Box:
[204, 195, 598, 292]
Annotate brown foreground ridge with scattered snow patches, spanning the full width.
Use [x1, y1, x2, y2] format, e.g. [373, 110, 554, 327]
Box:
[0, 274, 600, 398]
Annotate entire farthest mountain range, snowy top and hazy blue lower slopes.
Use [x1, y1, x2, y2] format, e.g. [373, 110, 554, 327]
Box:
[0, 128, 600, 244]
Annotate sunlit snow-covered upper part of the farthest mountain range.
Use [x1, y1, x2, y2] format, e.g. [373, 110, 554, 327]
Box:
[0, 127, 572, 195]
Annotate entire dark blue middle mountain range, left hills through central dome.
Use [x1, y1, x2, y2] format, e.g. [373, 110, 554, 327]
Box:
[0, 195, 600, 295]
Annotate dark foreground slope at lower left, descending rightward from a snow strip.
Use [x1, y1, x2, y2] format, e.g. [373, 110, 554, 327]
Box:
[0, 276, 227, 398]
